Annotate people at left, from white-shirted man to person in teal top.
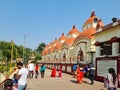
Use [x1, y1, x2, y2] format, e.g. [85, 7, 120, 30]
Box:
[3, 62, 46, 90]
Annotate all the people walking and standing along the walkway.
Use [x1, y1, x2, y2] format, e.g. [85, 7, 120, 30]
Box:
[3, 62, 118, 90]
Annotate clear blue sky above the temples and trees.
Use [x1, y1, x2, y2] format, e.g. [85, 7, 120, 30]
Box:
[0, 0, 120, 49]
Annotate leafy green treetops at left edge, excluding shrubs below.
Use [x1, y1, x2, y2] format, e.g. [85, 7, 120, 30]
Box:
[0, 41, 32, 62]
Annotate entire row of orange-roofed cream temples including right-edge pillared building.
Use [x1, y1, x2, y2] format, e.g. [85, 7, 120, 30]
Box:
[42, 11, 120, 64]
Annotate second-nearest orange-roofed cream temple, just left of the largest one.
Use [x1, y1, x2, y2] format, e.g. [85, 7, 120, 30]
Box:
[61, 25, 80, 63]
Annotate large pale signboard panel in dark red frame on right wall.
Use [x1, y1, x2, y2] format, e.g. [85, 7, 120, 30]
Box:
[97, 59, 117, 77]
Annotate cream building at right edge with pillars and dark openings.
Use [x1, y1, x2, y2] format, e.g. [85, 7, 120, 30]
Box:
[94, 20, 120, 57]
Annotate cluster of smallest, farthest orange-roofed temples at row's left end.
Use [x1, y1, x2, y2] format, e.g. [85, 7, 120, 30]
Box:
[42, 33, 66, 63]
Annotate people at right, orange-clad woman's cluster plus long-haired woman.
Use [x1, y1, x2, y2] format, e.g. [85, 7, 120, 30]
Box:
[73, 63, 118, 90]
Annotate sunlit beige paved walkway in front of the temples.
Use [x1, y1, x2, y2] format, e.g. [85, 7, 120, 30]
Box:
[27, 69, 120, 90]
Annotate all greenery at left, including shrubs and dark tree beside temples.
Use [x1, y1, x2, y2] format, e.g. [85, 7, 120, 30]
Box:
[0, 41, 45, 71]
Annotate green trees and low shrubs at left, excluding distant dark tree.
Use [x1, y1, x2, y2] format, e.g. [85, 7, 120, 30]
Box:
[0, 41, 33, 71]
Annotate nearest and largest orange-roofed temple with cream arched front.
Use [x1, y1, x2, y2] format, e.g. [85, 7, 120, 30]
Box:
[73, 11, 102, 64]
